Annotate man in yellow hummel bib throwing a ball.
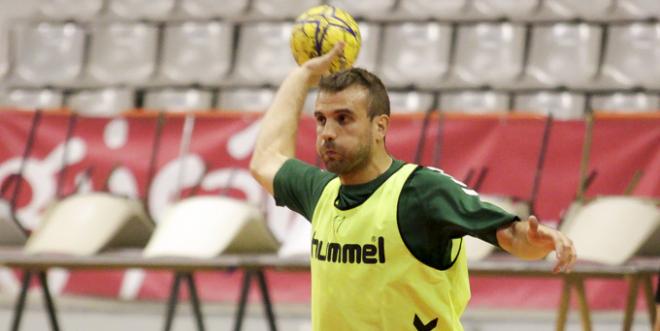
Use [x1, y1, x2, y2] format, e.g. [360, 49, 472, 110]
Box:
[250, 44, 575, 331]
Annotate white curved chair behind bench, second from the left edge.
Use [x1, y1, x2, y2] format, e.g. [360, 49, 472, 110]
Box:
[25, 193, 154, 256]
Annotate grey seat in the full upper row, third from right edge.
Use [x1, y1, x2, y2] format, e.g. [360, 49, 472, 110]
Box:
[452, 23, 525, 86]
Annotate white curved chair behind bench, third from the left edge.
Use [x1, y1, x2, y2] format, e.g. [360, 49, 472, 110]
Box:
[144, 196, 279, 258]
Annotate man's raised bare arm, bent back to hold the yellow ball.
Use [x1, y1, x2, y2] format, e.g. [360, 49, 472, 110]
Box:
[250, 44, 344, 194]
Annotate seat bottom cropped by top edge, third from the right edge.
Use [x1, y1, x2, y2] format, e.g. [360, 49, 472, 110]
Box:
[472, 0, 540, 19]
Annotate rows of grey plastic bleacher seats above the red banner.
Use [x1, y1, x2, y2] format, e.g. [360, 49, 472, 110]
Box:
[0, 0, 660, 118]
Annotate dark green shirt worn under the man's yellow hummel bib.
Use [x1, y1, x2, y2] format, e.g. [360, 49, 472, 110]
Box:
[273, 159, 518, 269]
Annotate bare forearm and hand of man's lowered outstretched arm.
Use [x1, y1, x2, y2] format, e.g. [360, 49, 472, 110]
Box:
[497, 216, 577, 272]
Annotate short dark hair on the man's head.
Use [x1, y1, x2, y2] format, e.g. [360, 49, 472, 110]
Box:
[319, 68, 390, 119]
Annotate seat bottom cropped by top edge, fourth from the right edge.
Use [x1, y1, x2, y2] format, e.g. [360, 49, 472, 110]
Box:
[399, 0, 468, 19]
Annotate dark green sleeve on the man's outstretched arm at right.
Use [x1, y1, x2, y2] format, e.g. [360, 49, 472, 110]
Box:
[410, 168, 518, 247]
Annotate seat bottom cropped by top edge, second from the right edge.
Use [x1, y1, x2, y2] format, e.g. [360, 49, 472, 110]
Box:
[543, 0, 616, 20]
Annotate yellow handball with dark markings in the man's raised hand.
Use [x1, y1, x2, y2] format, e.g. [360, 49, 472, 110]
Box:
[291, 5, 362, 72]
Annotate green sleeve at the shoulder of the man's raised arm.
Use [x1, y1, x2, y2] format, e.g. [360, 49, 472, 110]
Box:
[273, 159, 335, 221]
